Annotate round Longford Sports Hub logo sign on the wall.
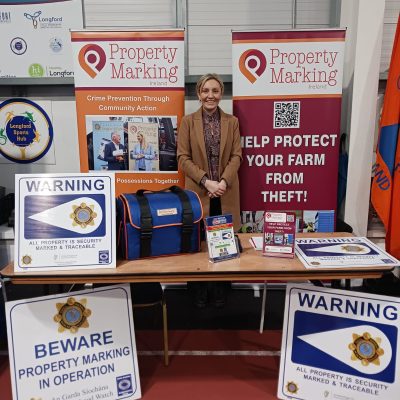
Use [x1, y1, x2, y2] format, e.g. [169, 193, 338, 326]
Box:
[0, 98, 56, 164]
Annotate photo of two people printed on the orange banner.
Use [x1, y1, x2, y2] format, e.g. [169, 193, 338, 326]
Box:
[86, 115, 178, 173]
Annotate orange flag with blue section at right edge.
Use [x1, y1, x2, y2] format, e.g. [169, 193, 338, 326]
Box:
[371, 14, 400, 259]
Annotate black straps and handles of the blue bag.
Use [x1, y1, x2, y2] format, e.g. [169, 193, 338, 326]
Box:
[136, 186, 194, 253]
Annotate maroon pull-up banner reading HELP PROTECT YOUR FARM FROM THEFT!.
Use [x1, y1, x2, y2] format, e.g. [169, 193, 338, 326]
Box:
[232, 30, 345, 232]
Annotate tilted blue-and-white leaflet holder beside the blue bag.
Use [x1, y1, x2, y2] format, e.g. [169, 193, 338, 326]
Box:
[204, 214, 239, 262]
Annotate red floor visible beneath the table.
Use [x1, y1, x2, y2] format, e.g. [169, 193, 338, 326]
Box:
[0, 331, 281, 400]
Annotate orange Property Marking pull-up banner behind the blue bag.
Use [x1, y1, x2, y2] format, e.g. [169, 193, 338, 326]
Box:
[71, 30, 185, 195]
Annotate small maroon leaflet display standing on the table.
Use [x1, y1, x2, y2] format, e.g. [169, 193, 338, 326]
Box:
[263, 211, 296, 258]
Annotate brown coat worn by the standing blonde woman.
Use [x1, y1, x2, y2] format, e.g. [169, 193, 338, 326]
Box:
[177, 108, 242, 231]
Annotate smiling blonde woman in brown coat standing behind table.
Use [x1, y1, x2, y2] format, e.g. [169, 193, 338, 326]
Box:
[177, 74, 242, 308]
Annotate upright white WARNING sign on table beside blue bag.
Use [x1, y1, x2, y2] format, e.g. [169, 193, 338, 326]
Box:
[14, 173, 116, 272]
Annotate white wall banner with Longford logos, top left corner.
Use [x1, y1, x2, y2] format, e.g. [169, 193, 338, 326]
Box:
[0, 0, 83, 82]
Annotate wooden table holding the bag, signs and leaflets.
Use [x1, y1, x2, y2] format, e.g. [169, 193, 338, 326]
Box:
[0, 232, 393, 284]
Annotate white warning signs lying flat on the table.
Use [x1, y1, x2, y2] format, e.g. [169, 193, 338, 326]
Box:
[296, 236, 400, 268]
